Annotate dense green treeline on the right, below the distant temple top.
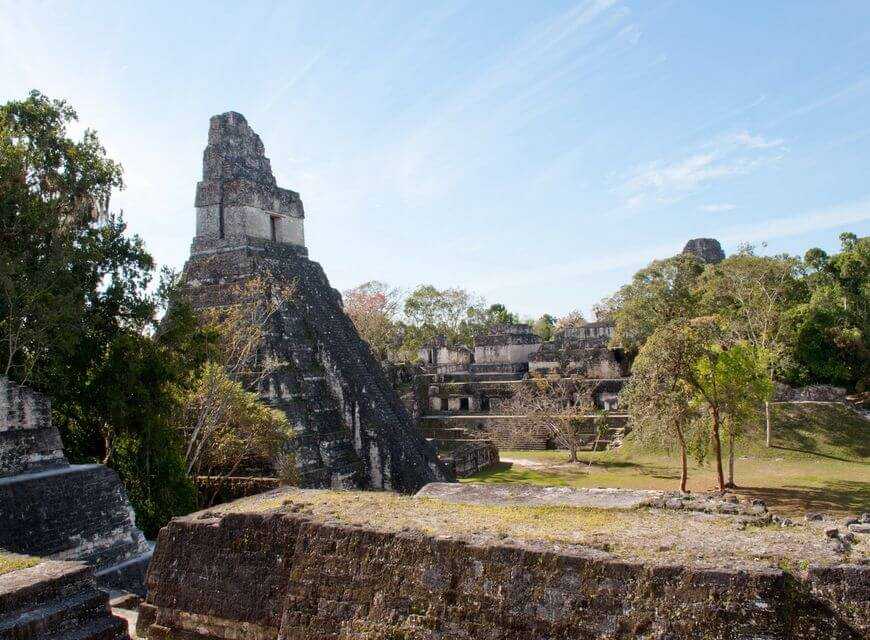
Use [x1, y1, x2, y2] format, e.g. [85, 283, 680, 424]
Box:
[602, 238, 870, 391]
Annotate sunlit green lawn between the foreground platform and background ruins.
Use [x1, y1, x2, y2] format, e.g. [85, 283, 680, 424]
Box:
[464, 404, 870, 515]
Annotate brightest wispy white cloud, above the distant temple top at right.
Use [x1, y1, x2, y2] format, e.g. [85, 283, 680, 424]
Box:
[621, 131, 787, 208]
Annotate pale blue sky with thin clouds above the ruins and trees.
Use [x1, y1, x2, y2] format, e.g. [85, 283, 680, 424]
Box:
[0, 0, 870, 315]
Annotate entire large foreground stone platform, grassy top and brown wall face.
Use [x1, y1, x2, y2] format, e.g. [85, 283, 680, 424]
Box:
[138, 488, 870, 640]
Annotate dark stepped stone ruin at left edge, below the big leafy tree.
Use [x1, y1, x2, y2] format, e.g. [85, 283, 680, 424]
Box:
[0, 378, 151, 594]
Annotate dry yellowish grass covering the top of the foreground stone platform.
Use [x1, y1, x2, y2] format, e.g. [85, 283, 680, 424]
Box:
[209, 488, 870, 568]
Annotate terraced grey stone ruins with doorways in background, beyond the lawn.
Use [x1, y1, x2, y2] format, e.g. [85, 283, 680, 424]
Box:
[418, 322, 629, 458]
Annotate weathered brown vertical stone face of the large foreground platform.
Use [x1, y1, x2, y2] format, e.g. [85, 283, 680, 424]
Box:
[137, 506, 870, 640]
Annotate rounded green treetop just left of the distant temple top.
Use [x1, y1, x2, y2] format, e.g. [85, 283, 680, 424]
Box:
[602, 253, 704, 354]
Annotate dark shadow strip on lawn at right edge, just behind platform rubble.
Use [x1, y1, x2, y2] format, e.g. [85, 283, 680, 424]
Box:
[736, 480, 870, 514]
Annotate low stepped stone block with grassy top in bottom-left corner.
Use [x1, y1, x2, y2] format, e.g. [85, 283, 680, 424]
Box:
[0, 562, 129, 640]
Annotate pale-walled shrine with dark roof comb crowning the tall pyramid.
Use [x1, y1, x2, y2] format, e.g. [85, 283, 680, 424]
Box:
[193, 111, 305, 252]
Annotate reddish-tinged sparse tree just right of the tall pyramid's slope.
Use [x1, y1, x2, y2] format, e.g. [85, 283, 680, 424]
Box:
[344, 280, 401, 362]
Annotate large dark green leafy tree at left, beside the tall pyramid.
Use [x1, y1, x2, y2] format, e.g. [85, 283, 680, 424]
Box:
[0, 91, 211, 536]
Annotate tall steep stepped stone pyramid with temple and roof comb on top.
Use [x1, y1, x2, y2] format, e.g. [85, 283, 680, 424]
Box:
[183, 112, 452, 492]
